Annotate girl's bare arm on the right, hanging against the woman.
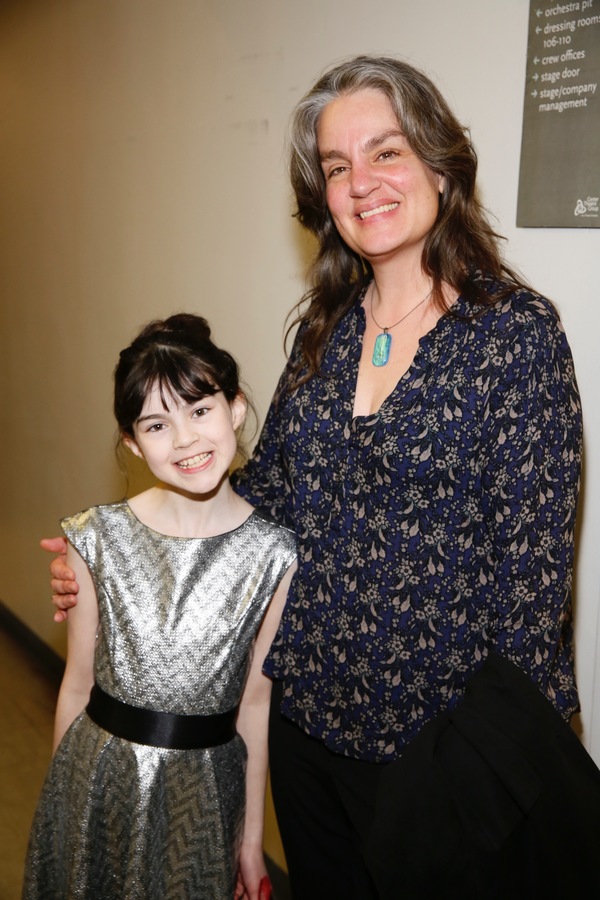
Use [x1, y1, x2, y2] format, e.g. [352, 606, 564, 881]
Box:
[236, 563, 296, 900]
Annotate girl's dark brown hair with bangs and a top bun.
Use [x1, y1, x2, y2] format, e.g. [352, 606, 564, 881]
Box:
[114, 313, 243, 437]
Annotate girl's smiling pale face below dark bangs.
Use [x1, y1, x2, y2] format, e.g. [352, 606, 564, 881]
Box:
[123, 385, 246, 495]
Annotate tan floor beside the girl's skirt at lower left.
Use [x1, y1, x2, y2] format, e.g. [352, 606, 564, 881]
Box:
[0, 628, 58, 900]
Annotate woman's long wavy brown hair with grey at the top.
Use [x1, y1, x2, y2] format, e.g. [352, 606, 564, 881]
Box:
[290, 56, 523, 381]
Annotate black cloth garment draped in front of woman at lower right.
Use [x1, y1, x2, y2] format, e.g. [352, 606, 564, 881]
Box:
[367, 655, 600, 900]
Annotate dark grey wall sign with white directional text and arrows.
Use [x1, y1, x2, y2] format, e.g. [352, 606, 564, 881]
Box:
[517, 0, 600, 228]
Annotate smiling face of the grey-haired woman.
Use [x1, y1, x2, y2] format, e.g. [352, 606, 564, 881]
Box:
[317, 88, 444, 267]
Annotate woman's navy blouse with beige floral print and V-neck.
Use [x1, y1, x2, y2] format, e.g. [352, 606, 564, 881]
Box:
[234, 282, 581, 761]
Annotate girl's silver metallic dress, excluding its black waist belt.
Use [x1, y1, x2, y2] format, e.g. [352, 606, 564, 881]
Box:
[23, 501, 296, 900]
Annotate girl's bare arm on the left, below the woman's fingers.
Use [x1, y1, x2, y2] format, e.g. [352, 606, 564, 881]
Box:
[53, 544, 98, 751]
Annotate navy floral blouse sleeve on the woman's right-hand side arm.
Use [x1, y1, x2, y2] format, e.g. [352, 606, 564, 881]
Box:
[480, 312, 581, 716]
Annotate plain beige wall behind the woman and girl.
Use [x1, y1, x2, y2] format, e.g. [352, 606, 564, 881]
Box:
[0, 0, 600, 808]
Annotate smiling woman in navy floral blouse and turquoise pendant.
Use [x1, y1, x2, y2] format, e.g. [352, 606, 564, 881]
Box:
[45, 56, 581, 900]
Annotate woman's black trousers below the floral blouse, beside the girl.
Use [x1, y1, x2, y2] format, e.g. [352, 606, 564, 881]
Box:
[269, 684, 385, 900]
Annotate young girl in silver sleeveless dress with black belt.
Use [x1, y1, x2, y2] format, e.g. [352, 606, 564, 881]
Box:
[23, 315, 296, 900]
